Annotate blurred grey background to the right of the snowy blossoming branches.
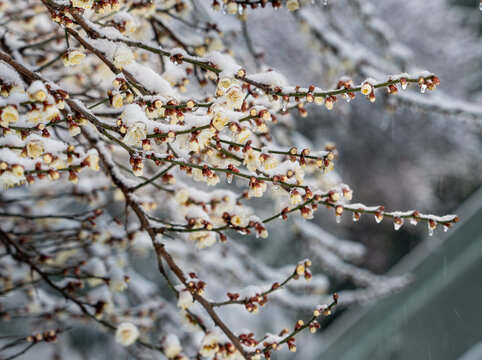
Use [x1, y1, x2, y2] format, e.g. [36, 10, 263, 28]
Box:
[217, 0, 482, 360]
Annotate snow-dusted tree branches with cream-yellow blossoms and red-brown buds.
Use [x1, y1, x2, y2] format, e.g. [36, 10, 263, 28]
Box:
[0, 0, 468, 360]
